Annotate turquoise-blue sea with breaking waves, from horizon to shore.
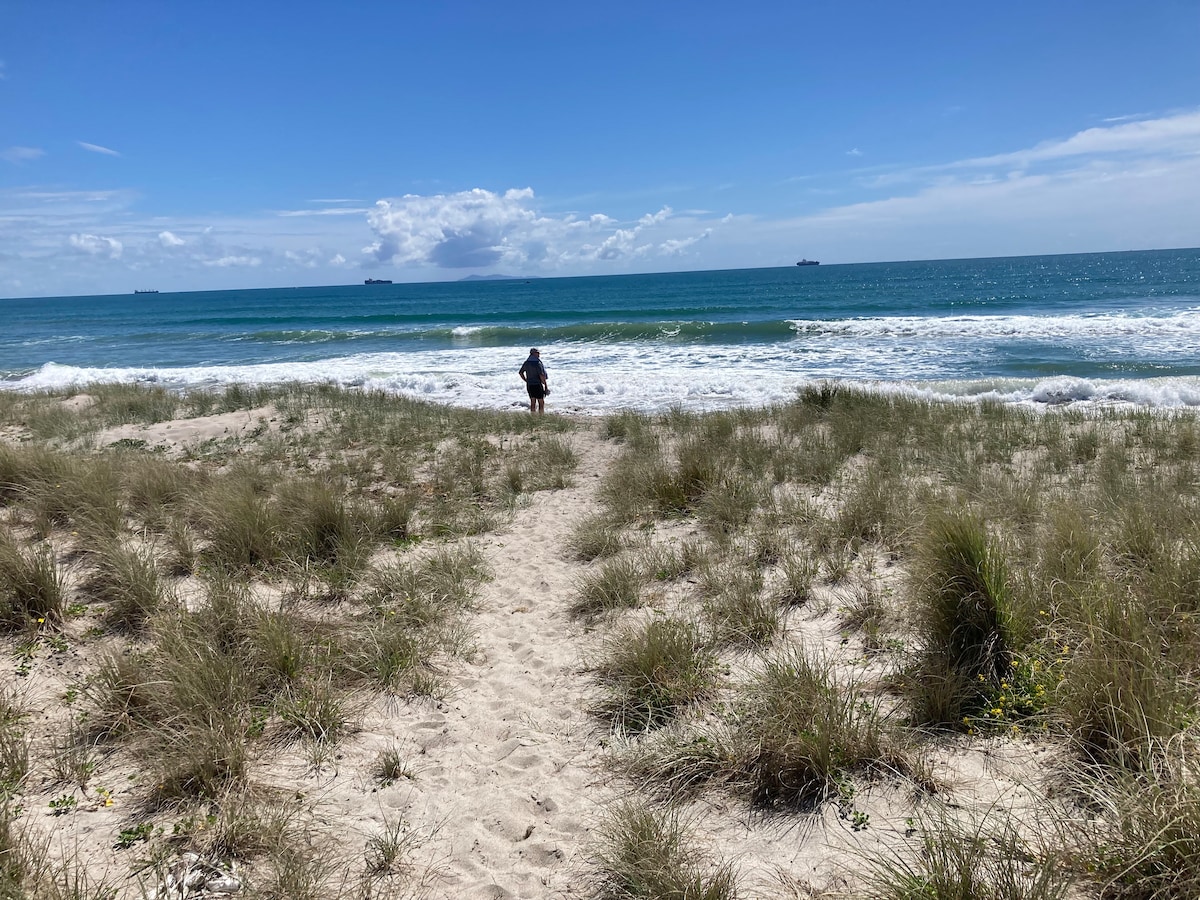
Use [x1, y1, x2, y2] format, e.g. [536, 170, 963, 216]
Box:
[0, 250, 1200, 413]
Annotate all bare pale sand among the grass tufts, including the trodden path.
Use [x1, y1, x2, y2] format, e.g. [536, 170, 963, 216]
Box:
[5, 388, 1195, 899]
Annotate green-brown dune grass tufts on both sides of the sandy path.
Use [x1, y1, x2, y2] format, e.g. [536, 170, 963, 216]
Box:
[7, 384, 1200, 900]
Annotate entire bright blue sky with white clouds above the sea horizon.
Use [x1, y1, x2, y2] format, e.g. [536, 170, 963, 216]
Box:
[0, 0, 1200, 296]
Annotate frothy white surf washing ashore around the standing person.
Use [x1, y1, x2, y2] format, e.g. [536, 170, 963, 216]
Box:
[2, 344, 1200, 414]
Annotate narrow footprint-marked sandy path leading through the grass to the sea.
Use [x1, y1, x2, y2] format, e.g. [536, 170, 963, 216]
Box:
[340, 434, 614, 899]
